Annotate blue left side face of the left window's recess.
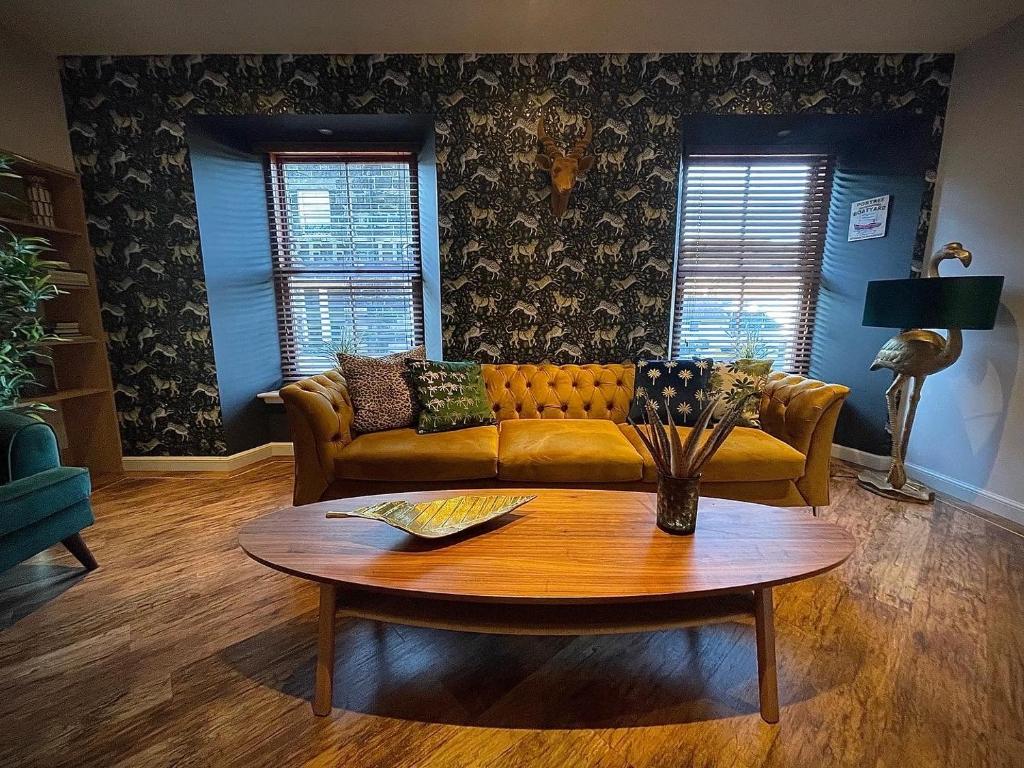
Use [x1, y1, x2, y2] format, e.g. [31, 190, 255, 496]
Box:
[188, 126, 281, 454]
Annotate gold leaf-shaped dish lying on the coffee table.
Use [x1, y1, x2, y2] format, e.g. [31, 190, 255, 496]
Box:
[327, 496, 537, 539]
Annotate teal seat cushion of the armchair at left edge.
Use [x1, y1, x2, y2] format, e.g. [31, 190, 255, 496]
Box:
[0, 467, 91, 536]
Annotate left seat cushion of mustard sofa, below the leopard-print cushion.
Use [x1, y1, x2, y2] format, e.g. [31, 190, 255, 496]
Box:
[335, 426, 498, 481]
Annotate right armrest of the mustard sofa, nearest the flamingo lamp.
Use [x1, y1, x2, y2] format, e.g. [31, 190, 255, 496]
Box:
[760, 374, 850, 506]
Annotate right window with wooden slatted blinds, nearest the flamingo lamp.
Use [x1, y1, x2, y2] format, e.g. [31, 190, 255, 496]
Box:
[672, 155, 831, 374]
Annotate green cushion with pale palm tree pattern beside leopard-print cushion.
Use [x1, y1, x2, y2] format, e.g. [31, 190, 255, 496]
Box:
[409, 360, 495, 434]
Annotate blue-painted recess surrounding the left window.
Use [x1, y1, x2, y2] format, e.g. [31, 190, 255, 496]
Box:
[187, 115, 441, 453]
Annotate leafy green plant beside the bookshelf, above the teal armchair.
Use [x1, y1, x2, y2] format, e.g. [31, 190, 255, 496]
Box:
[0, 157, 60, 421]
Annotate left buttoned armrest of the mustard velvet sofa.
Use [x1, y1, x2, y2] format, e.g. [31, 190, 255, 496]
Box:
[281, 371, 352, 505]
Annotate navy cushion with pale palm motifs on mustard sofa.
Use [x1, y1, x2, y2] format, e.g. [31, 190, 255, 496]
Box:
[630, 357, 715, 427]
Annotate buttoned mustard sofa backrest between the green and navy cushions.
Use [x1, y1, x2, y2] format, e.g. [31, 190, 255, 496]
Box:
[482, 364, 634, 424]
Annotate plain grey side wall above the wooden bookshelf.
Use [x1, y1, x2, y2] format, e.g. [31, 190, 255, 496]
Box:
[0, 31, 75, 169]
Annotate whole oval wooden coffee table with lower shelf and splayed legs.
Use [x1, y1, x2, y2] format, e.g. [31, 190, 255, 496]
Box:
[239, 488, 854, 723]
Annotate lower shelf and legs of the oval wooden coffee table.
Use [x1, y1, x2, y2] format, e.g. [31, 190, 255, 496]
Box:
[312, 583, 778, 723]
